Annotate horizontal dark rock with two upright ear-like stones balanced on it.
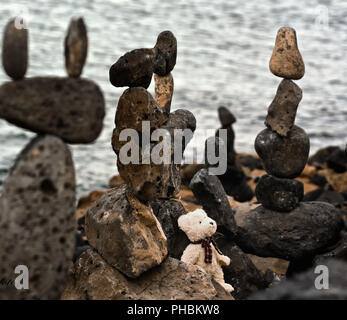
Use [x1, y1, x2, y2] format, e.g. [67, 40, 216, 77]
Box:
[0, 18, 105, 143]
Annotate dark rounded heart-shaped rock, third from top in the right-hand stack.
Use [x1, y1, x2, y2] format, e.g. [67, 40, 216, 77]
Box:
[254, 125, 310, 178]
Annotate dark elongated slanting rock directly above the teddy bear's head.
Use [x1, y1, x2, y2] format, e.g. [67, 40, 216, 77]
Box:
[189, 169, 235, 232]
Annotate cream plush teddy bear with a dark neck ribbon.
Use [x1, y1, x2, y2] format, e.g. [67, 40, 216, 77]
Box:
[178, 209, 234, 293]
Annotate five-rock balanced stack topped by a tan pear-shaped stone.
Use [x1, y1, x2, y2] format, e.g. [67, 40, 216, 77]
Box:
[235, 27, 343, 262]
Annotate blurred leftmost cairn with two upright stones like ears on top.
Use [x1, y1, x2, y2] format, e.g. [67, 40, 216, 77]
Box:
[0, 18, 105, 299]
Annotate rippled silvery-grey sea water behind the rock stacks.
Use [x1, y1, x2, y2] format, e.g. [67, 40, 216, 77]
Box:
[0, 0, 347, 195]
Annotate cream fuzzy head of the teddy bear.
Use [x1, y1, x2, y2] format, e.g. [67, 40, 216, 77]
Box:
[178, 209, 217, 242]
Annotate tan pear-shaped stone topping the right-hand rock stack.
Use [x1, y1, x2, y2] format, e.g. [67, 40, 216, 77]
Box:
[269, 27, 305, 80]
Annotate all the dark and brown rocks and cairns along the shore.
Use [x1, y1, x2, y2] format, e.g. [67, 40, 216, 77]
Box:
[0, 18, 347, 300]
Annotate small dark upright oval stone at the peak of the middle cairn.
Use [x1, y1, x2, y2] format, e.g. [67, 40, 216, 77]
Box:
[154, 31, 177, 76]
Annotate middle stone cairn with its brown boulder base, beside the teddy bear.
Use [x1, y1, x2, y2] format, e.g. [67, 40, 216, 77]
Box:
[66, 31, 232, 299]
